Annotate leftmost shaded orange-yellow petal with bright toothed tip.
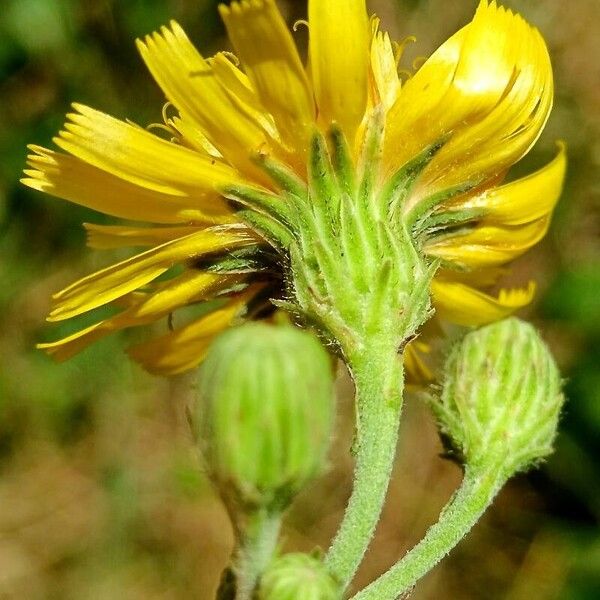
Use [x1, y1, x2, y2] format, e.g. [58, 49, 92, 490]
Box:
[21, 146, 232, 223]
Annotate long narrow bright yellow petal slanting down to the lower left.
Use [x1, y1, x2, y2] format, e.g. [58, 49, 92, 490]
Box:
[48, 227, 255, 321]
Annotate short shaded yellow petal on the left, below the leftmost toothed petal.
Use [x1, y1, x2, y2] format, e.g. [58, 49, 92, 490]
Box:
[83, 223, 204, 250]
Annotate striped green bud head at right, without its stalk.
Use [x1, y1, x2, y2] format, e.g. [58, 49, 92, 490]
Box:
[432, 318, 563, 476]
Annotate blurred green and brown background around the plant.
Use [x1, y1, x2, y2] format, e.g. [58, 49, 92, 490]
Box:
[0, 0, 600, 600]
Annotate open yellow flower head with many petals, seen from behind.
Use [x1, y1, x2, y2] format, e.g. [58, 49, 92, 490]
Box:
[23, 0, 566, 374]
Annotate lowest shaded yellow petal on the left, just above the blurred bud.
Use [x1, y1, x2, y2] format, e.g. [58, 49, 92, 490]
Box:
[127, 293, 250, 375]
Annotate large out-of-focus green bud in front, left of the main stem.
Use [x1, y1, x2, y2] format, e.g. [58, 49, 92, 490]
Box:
[196, 323, 333, 509]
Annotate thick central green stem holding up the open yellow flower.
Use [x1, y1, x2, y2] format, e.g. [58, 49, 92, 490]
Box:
[325, 344, 404, 589]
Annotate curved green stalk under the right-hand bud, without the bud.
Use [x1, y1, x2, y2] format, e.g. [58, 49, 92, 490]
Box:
[352, 467, 507, 600]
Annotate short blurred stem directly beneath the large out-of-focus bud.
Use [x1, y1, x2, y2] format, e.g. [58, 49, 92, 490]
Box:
[233, 508, 281, 600]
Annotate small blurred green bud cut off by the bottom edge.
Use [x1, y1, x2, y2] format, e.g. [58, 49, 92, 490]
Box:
[258, 553, 341, 600]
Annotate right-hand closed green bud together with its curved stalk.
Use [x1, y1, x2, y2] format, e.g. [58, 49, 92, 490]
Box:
[352, 318, 564, 600]
